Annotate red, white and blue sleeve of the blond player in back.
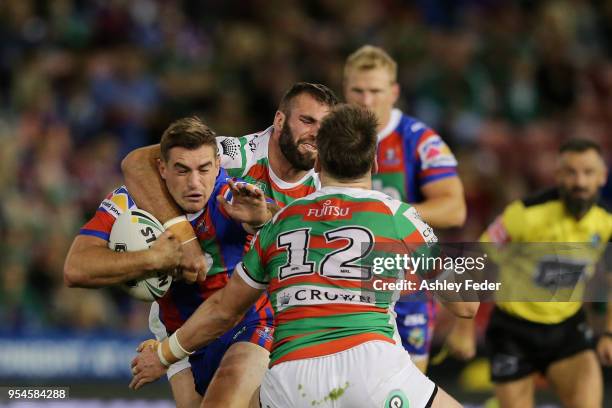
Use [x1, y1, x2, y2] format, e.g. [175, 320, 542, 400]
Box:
[413, 123, 457, 186]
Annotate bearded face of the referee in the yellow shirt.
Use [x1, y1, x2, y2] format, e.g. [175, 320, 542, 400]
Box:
[557, 149, 607, 216]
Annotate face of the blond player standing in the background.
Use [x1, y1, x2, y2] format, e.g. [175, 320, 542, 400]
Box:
[344, 68, 399, 130]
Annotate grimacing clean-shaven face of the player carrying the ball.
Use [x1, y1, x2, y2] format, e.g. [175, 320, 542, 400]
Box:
[159, 145, 219, 213]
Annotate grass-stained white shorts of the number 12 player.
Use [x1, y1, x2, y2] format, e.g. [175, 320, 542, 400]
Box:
[259, 341, 437, 408]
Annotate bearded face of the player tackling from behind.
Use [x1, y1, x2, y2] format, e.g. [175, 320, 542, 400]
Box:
[279, 94, 329, 170]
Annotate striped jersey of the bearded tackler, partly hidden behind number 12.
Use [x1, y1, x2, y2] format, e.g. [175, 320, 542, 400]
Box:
[217, 127, 320, 206]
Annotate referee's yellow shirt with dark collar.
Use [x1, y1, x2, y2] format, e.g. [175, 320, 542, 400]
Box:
[481, 189, 612, 324]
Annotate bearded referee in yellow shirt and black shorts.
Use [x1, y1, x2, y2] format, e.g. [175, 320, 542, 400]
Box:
[481, 140, 612, 408]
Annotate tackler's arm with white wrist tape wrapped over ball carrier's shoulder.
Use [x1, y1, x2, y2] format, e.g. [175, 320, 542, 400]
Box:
[121, 144, 207, 282]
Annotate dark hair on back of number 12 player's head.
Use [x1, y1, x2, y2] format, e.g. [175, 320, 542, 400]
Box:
[317, 104, 378, 180]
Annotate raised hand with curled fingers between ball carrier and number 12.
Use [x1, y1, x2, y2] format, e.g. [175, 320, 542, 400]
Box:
[217, 179, 272, 226]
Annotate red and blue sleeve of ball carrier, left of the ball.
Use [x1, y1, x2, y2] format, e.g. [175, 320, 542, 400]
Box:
[79, 186, 134, 241]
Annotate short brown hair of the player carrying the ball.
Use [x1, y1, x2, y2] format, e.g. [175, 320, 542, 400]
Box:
[160, 116, 217, 162]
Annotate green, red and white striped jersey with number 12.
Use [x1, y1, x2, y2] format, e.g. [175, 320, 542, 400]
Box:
[236, 187, 437, 365]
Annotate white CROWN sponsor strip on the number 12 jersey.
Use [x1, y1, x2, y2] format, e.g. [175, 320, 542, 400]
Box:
[276, 285, 376, 310]
